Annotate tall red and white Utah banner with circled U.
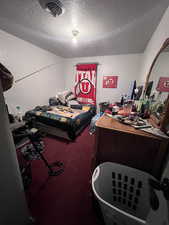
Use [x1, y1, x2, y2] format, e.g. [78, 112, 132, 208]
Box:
[75, 64, 97, 105]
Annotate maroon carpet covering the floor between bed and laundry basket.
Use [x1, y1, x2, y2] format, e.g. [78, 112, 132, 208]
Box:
[28, 128, 103, 225]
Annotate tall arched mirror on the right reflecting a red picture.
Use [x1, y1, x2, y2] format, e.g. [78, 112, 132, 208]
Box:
[144, 39, 169, 133]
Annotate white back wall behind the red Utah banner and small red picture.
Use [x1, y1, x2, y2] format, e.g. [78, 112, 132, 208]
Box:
[64, 54, 142, 103]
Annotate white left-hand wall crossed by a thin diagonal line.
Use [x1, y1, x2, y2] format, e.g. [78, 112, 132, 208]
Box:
[0, 30, 64, 113]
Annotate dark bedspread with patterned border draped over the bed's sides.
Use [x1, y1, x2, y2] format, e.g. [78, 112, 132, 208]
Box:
[25, 105, 96, 139]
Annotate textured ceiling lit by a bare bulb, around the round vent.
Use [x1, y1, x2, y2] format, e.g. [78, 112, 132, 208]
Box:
[0, 0, 169, 58]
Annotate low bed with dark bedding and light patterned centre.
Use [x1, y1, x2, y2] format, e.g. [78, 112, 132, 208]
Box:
[24, 105, 96, 140]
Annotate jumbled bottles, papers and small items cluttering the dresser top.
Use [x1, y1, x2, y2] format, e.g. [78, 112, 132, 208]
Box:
[99, 89, 167, 138]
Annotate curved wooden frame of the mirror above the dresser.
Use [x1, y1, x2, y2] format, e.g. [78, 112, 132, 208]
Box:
[143, 38, 169, 133]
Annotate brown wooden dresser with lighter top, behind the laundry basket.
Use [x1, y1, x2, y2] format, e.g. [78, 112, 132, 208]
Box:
[92, 114, 169, 178]
